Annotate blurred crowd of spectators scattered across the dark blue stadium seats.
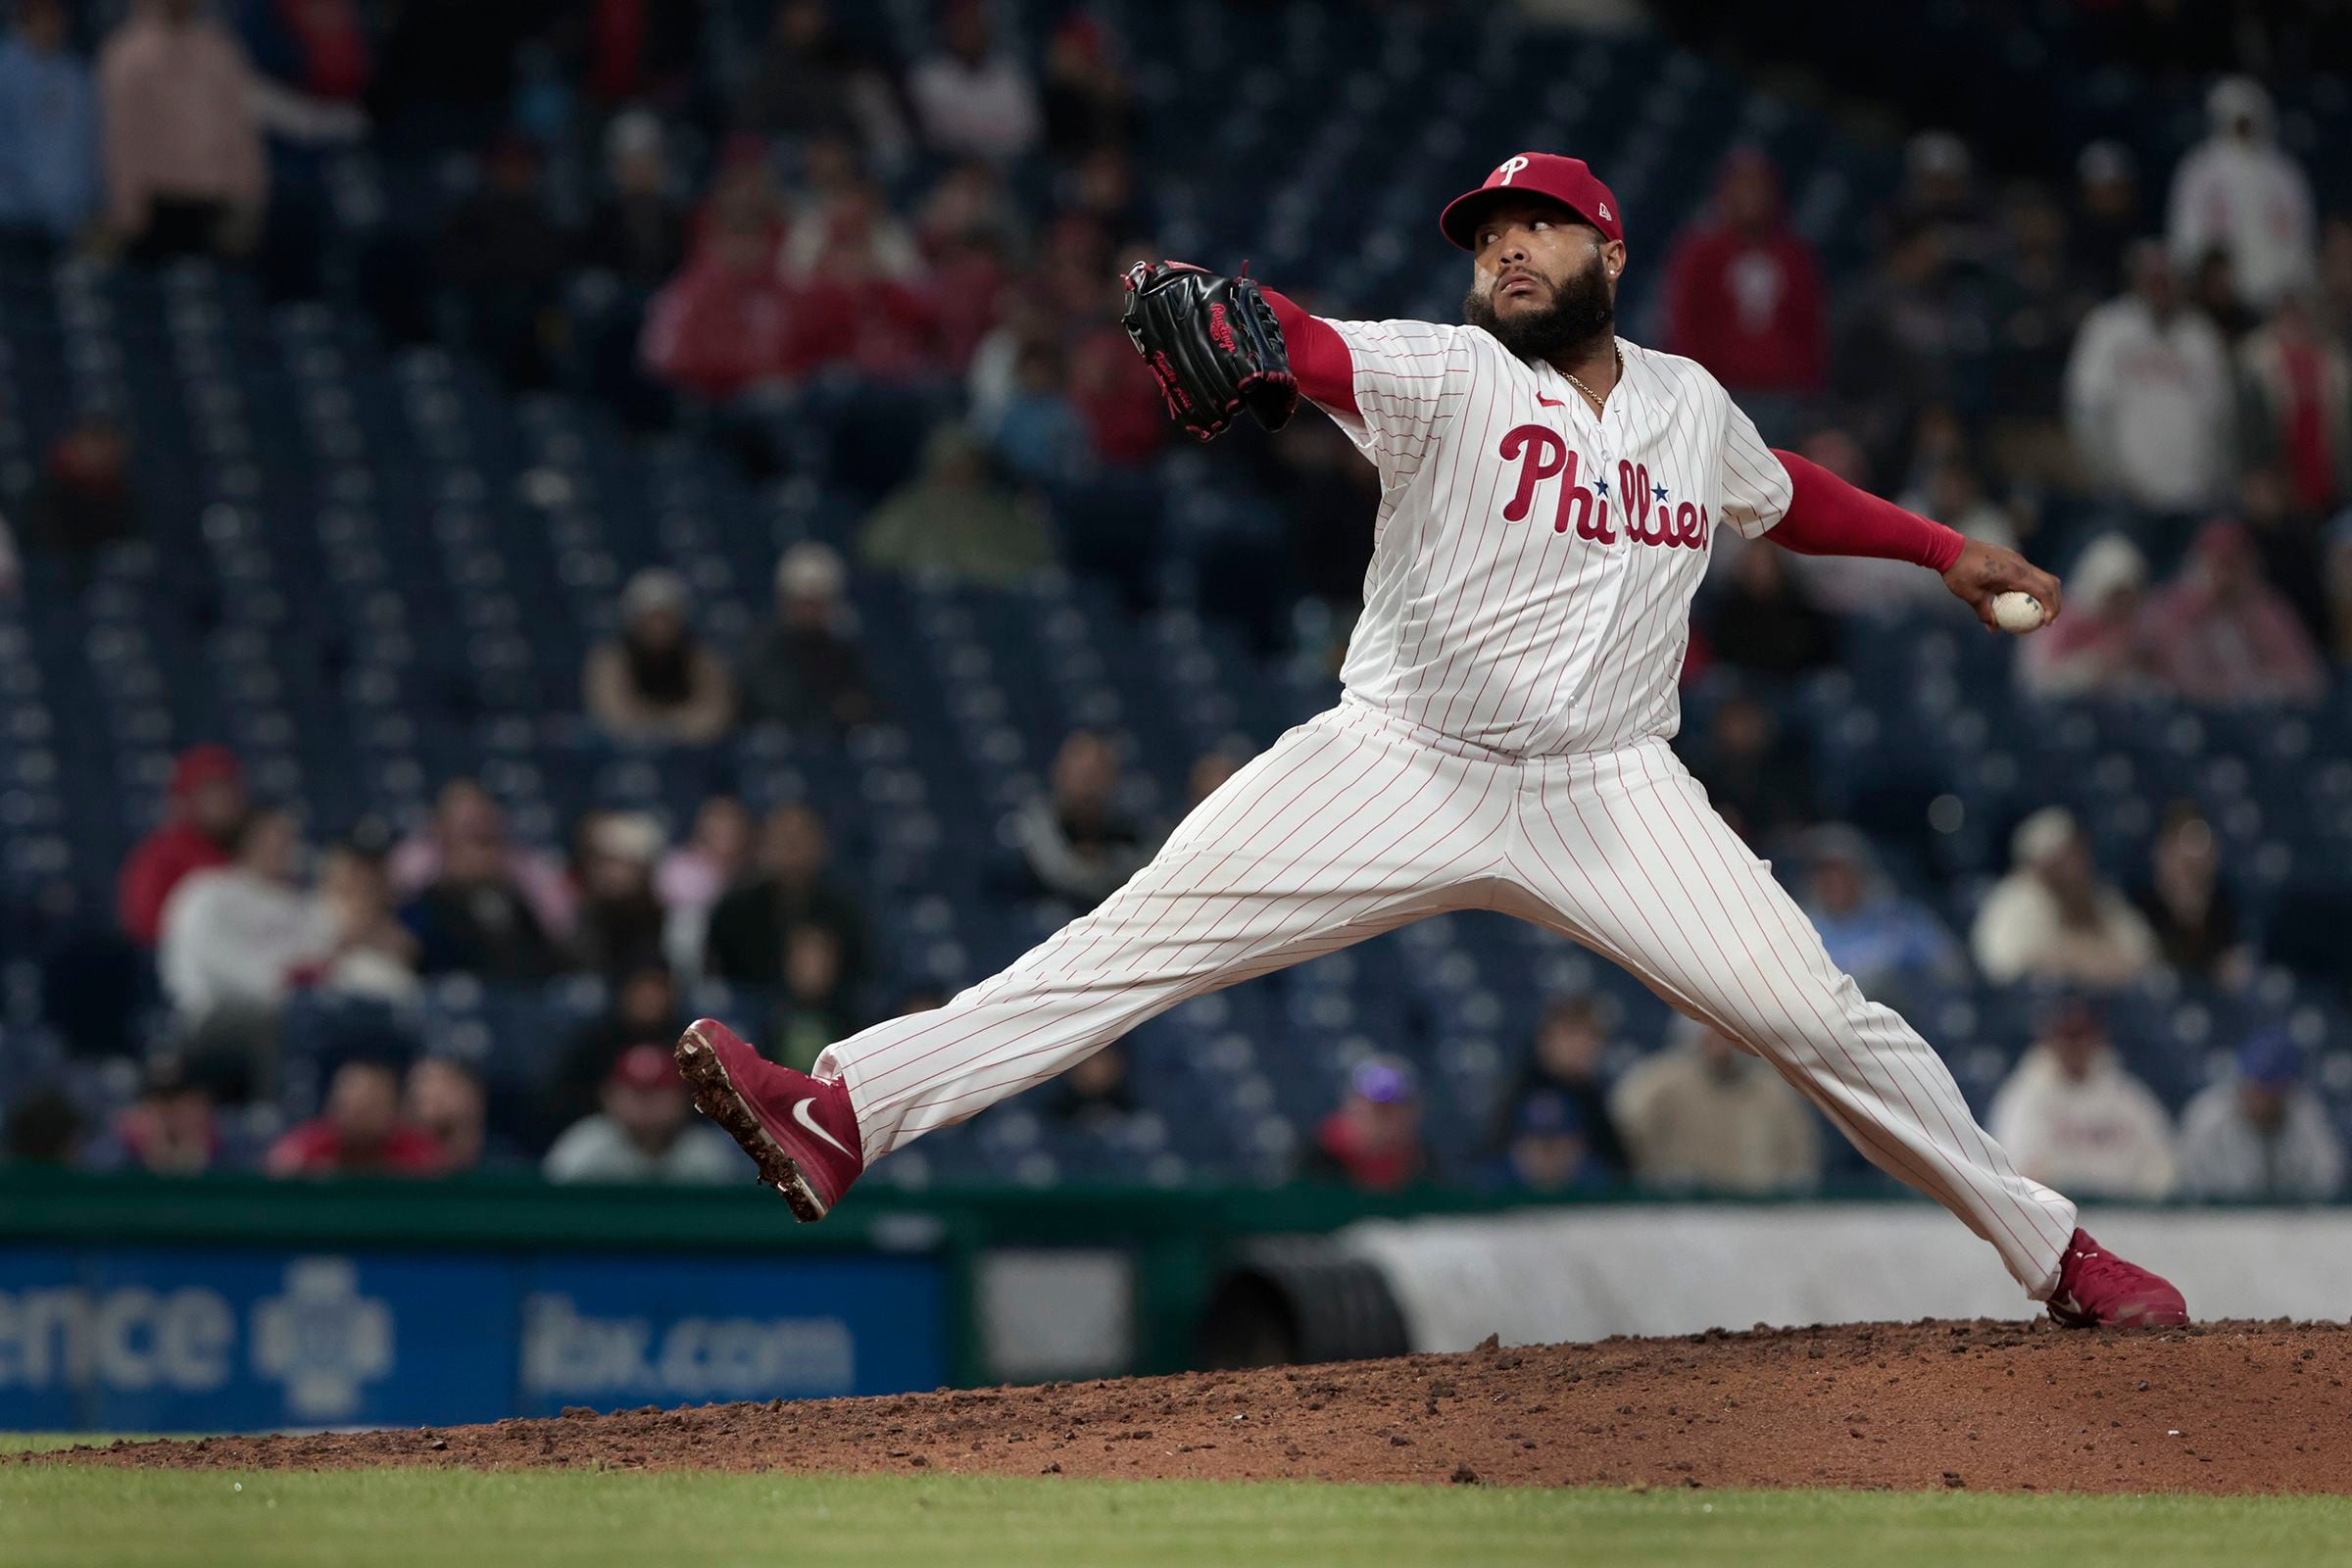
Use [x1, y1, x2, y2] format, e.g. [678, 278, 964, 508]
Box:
[0, 0, 2352, 1197]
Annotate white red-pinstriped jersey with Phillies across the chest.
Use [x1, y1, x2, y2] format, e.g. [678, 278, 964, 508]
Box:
[1327, 322, 1789, 757]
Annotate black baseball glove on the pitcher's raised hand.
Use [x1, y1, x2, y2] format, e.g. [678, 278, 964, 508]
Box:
[1119, 261, 1298, 442]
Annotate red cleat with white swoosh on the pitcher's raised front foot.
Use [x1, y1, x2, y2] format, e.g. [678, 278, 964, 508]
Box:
[677, 1018, 865, 1225]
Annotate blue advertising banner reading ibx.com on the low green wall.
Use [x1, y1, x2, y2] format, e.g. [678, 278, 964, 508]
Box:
[0, 1249, 948, 1432]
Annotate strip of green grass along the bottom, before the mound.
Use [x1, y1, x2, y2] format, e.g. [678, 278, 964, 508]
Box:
[0, 1439, 2352, 1568]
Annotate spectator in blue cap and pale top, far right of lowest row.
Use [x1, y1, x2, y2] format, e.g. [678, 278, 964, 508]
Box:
[2180, 1030, 2345, 1203]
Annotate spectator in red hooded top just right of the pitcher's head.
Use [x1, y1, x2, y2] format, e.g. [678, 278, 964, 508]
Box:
[1665, 148, 1823, 402]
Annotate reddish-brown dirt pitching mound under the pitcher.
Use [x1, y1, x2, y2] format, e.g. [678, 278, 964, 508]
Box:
[33, 1321, 2352, 1493]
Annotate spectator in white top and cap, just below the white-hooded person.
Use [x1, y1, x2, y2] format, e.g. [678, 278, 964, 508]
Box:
[2065, 240, 2234, 513]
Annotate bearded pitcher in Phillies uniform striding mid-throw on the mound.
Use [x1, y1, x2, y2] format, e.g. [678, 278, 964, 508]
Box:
[677, 153, 2187, 1326]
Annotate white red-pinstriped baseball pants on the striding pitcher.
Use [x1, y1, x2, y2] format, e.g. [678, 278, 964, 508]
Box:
[818, 703, 2075, 1300]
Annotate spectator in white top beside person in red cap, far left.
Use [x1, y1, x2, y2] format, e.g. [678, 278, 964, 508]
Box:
[155, 808, 339, 1022]
